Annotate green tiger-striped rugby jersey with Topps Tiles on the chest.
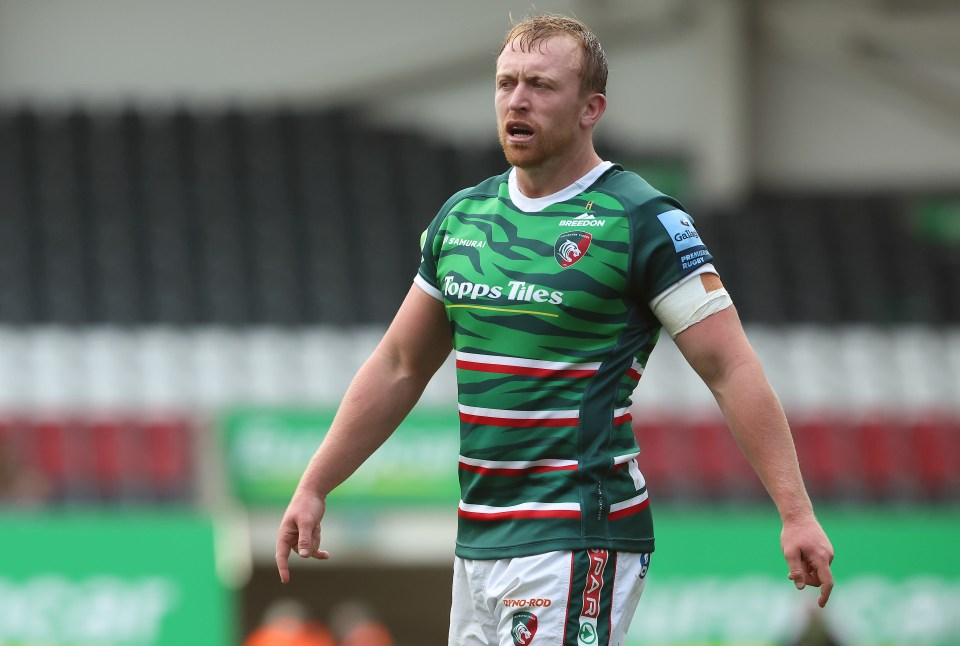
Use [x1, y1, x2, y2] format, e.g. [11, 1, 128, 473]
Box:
[416, 163, 711, 559]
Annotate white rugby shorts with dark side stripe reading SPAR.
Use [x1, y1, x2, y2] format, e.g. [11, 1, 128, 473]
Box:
[448, 550, 650, 646]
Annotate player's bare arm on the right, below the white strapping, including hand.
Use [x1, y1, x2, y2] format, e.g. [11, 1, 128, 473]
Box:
[675, 305, 833, 607]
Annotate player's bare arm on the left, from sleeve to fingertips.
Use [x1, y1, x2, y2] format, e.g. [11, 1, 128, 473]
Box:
[276, 285, 451, 583]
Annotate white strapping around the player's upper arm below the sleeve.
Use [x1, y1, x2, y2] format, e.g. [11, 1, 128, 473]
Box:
[650, 264, 733, 338]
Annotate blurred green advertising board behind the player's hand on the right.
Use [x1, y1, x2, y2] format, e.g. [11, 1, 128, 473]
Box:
[627, 507, 960, 646]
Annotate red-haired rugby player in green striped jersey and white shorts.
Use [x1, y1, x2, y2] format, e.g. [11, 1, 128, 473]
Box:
[277, 16, 833, 646]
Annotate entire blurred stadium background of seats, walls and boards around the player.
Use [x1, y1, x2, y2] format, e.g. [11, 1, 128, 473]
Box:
[0, 0, 960, 646]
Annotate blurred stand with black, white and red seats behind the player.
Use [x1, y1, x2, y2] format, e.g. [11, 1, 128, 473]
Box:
[0, 109, 960, 503]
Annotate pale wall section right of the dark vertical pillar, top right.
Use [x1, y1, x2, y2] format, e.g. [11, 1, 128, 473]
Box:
[757, 2, 960, 188]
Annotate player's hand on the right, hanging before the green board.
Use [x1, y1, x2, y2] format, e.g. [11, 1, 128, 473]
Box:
[780, 516, 833, 608]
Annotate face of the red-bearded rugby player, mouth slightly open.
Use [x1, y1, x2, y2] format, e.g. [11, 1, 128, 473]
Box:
[496, 36, 586, 169]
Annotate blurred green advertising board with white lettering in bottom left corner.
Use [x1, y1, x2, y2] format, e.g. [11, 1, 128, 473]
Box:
[0, 512, 235, 646]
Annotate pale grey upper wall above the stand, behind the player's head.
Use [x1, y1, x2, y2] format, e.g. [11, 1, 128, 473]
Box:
[0, 0, 960, 198]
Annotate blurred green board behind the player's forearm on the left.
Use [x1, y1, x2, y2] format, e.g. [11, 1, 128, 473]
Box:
[220, 408, 460, 506]
